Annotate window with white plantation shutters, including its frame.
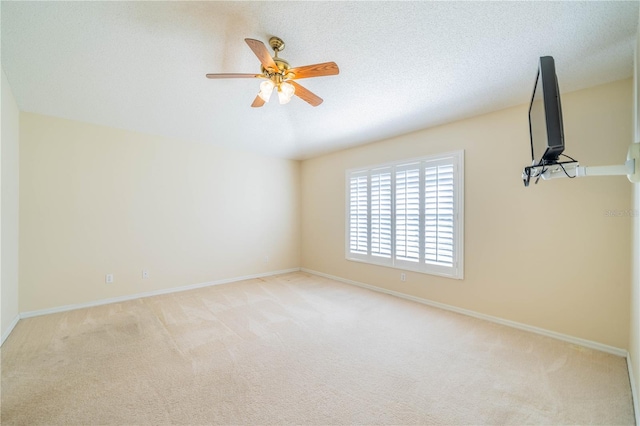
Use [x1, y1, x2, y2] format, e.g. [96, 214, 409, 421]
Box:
[346, 151, 464, 279]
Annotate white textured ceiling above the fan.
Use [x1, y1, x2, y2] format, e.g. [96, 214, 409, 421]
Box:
[1, 1, 638, 159]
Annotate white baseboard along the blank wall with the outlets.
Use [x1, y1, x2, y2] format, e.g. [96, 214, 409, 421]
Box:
[20, 268, 300, 320]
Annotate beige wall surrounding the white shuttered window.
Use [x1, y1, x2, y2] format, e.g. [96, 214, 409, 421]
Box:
[302, 79, 632, 348]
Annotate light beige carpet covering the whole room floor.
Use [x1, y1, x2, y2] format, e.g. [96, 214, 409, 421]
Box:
[1, 273, 634, 425]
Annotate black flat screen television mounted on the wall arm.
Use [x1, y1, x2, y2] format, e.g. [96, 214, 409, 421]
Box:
[529, 56, 564, 166]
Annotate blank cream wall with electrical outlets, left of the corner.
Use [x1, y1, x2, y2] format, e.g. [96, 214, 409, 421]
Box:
[20, 113, 300, 312]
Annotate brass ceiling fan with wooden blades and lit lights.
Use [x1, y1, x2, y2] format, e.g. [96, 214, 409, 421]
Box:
[207, 37, 340, 108]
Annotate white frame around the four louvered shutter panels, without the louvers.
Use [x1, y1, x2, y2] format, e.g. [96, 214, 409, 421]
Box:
[345, 150, 464, 280]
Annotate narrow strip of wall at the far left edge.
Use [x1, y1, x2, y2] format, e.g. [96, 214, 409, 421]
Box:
[0, 71, 20, 339]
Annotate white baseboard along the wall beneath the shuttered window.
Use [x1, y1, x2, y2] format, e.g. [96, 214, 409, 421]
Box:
[300, 268, 627, 358]
